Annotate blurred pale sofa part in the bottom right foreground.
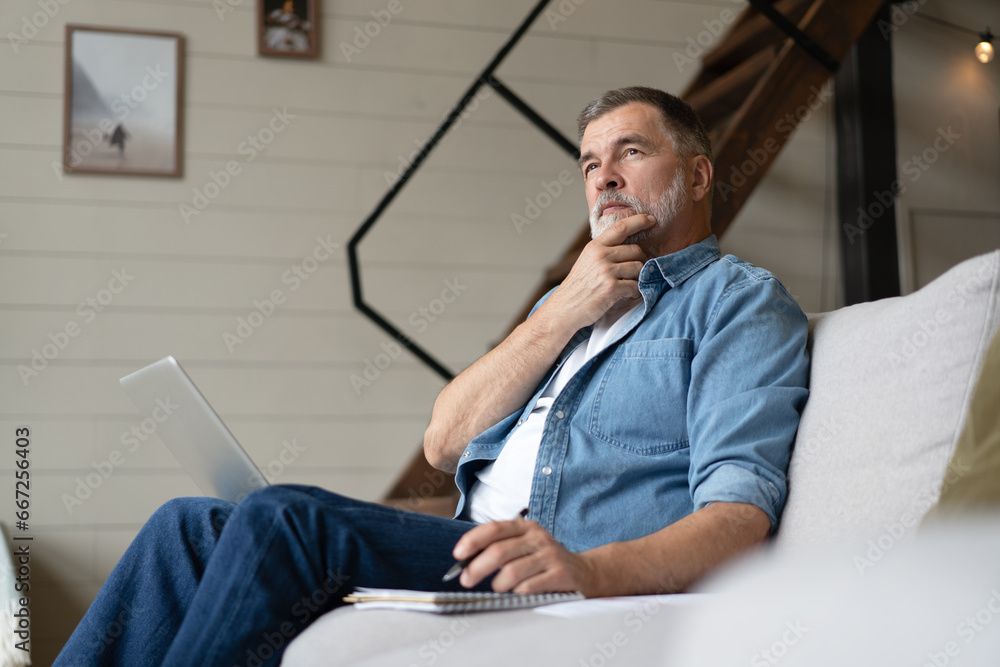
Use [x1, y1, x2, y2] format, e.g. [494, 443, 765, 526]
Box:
[664, 515, 1000, 667]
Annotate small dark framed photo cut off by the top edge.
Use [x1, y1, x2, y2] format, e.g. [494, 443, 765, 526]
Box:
[257, 0, 320, 58]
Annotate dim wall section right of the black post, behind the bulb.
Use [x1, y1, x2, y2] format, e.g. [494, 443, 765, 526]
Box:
[896, 0, 1000, 294]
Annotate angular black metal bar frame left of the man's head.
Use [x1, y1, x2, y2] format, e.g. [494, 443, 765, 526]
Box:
[347, 0, 580, 380]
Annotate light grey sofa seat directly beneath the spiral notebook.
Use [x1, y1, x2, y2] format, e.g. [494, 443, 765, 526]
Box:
[281, 595, 705, 667]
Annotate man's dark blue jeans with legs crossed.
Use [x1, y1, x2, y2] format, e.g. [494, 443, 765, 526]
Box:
[54, 485, 489, 667]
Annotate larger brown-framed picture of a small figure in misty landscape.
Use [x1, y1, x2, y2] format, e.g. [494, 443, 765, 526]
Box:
[63, 25, 184, 178]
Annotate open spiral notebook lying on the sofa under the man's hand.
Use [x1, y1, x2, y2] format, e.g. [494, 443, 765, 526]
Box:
[344, 587, 583, 614]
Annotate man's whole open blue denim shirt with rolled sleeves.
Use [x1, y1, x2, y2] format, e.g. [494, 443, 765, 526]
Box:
[455, 236, 809, 551]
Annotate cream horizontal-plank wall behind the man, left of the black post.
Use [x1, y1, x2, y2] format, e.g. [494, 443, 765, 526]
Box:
[0, 0, 836, 665]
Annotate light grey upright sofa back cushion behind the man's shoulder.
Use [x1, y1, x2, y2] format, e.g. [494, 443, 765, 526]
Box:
[775, 251, 1000, 555]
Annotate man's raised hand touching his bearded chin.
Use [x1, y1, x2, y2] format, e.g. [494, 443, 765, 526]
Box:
[542, 214, 656, 331]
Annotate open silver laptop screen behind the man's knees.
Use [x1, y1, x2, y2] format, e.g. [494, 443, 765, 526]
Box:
[120, 357, 268, 503]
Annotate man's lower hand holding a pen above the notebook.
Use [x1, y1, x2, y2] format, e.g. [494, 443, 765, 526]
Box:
[452, 519, 594, 597]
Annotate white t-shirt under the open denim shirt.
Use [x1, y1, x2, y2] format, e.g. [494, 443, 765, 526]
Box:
[465, 303, 642, 523]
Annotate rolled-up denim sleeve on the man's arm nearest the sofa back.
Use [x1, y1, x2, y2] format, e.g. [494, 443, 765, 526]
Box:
[687, 278, 809, 532]
